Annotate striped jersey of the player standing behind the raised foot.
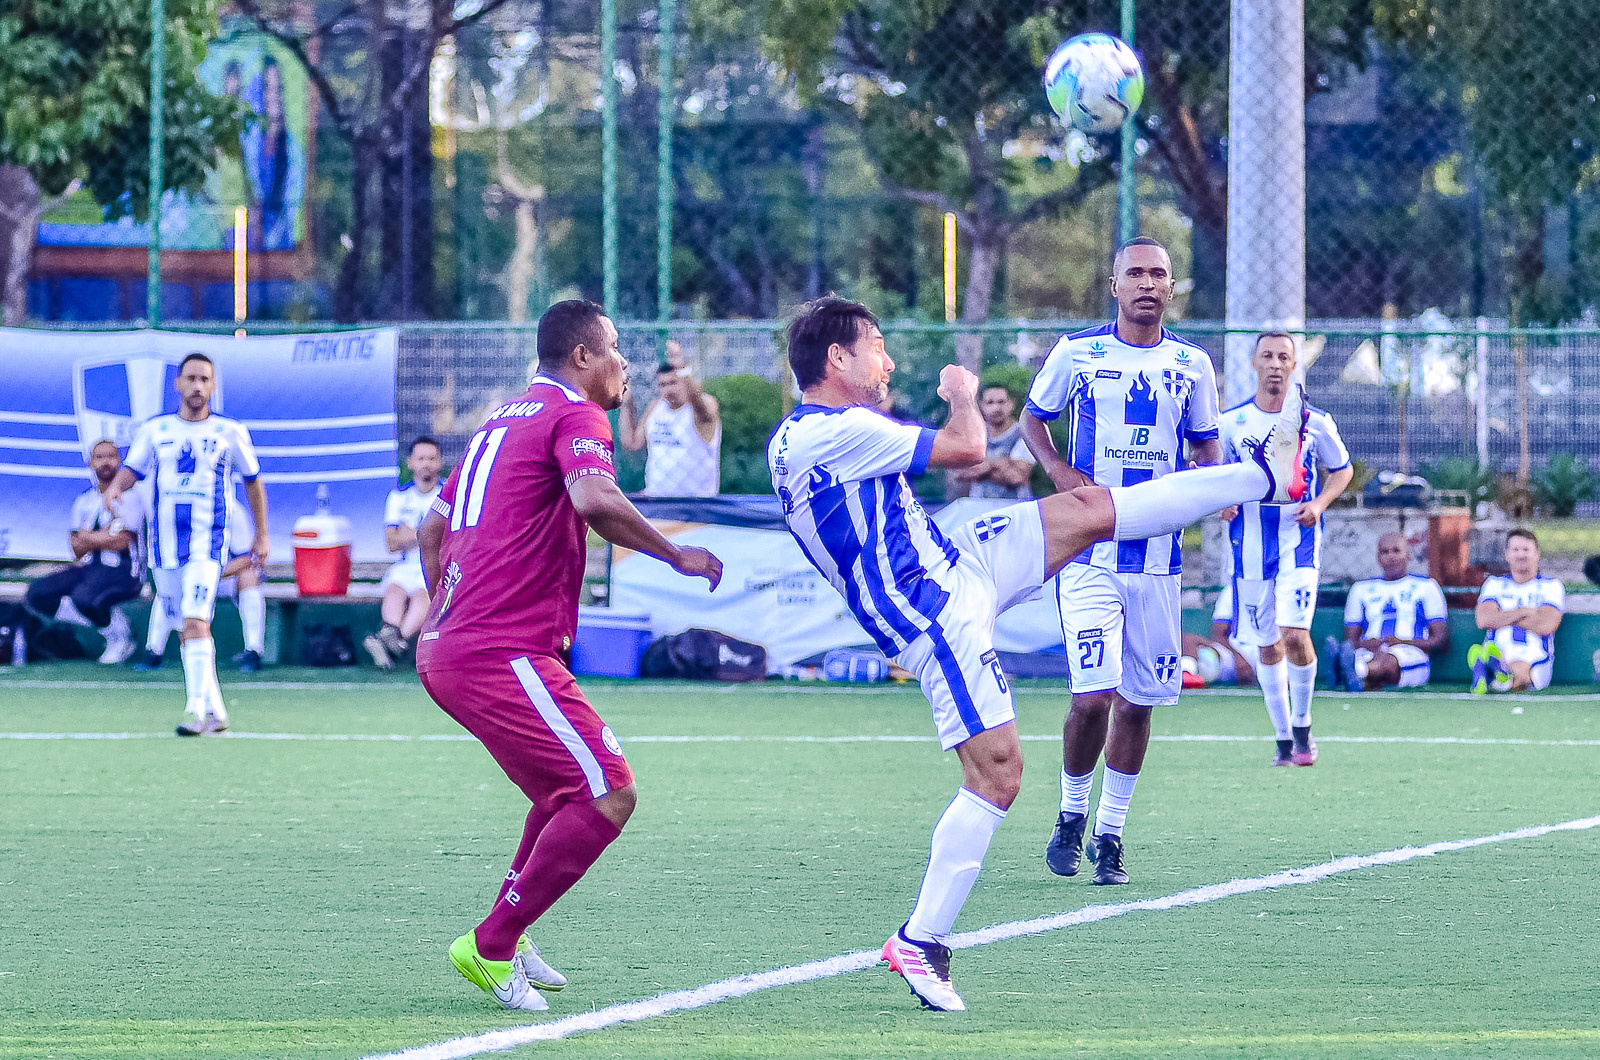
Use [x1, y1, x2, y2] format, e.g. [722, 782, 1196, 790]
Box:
[1222, 399, 1350, 580]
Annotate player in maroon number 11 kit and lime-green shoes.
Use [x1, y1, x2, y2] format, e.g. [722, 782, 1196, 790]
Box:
[416, 299, 722, 1010]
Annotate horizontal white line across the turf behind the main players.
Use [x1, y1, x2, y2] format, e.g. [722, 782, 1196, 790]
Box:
[0, 732, 1600, 748]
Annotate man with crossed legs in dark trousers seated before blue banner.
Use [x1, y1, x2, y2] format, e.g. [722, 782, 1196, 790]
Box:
[24, 439, 144, 666]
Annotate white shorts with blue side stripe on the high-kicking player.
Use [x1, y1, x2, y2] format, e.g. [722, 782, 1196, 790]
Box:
[894, 503, 1045, 751]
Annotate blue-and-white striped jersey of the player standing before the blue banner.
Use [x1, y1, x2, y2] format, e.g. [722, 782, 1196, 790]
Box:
[123, 413, 261, 570]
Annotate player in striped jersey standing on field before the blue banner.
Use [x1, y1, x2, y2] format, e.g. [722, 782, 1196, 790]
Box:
[106, 352, 267, 737]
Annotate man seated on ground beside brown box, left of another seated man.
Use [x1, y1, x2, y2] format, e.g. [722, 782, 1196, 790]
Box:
[1325, 532, 1450, 692]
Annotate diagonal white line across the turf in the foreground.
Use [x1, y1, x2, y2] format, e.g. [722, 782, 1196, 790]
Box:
[366, 817, 1600, 1060]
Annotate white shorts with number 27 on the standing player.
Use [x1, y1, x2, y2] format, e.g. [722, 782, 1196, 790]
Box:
[1056, 564, 1182, 706]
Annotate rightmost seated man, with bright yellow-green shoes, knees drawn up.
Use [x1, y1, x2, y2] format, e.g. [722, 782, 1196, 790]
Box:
[1467, 530, 1566, 695]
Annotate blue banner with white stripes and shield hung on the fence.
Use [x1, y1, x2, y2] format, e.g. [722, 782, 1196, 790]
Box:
[0, 328, 398, 562]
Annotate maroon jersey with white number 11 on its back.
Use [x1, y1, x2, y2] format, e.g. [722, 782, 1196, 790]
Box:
[416, 376, 616, 671]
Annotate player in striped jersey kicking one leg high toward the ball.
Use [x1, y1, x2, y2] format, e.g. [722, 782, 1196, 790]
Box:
[764, 298, 1301, 1012]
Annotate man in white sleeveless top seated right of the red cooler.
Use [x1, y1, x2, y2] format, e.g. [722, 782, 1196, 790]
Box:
[362, 436, 445, 669]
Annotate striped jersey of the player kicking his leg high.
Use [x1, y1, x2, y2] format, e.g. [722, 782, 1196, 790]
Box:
[766, 405, 960, 655]
